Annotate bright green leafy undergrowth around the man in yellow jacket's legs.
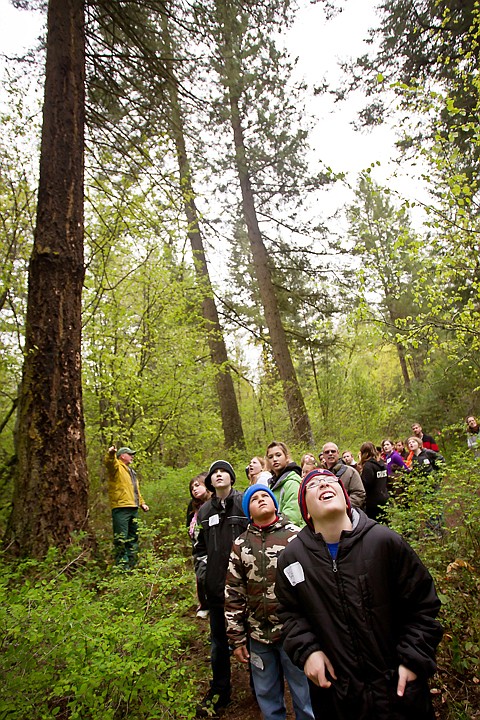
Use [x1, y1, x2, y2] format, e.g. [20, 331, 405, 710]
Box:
[0, 464, 207, 720]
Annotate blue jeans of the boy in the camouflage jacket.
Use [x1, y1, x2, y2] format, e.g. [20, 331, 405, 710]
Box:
[250, 638, 314, 720]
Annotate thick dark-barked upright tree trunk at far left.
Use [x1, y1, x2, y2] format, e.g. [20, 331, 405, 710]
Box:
[6, 0, 88, 557]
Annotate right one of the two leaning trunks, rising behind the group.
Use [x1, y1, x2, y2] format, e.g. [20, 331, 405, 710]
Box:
[230, 91, 313, 446]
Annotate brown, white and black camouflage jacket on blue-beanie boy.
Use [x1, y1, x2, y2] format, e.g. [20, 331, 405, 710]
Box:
[225, 516, 299, 648]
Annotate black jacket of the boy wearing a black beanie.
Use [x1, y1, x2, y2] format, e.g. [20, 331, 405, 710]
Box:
[193, 490, 248, 606]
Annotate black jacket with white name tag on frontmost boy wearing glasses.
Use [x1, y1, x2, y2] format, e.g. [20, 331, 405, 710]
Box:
[275, 509, 442, 720]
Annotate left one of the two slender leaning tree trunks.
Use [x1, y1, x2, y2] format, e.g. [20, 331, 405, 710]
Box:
[164, 18, 245, 450]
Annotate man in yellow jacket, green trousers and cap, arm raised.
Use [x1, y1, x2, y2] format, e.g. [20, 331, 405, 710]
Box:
[105, 445, 149, 570]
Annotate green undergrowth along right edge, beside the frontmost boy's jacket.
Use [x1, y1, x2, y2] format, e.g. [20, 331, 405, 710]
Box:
[388, 454, 480, 720]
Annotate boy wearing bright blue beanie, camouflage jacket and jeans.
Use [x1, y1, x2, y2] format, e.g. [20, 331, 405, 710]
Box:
[225, 485, 313, 720]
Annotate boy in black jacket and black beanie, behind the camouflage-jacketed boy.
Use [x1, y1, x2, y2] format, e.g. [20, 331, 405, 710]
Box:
[193, 460, 248, 717]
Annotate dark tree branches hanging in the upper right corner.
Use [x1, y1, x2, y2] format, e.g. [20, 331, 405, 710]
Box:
[339, 0, 480, 178]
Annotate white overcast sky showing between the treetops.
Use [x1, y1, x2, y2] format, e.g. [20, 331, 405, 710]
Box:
[0, 0, 428, 222]
